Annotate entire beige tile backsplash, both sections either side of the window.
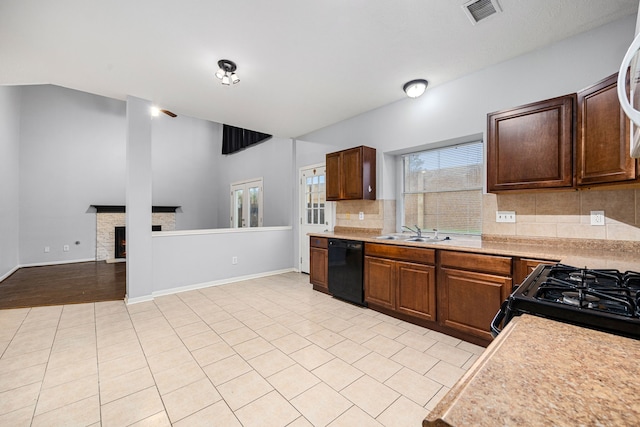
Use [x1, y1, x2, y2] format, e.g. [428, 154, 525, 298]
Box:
[336, 189, 640, 246]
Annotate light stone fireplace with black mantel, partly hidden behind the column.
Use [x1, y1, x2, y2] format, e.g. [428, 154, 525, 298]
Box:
[92, 205, 180, 261]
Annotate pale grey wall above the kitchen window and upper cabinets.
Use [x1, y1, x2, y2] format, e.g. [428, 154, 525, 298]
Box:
[299, 16, 635, 159]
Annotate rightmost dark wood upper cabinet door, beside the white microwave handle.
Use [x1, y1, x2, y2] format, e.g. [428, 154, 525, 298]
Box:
[576, 74, 637, 185]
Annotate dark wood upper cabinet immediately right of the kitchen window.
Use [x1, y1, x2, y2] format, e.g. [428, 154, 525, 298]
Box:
[487, 94, 576, 192]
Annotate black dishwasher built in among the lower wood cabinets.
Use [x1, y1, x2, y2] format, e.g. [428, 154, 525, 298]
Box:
[328, 239, 366, 306]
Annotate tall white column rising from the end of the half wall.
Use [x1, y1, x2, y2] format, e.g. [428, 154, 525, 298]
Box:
[126, 96, 153, 302]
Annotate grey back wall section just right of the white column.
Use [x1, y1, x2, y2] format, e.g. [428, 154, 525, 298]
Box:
[152, 113, 226, 230]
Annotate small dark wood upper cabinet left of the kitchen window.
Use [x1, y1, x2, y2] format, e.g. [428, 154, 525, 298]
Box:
[326, 146, 376, 201]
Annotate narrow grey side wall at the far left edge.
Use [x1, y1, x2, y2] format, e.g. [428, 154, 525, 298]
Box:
[0, 86, 20, 280]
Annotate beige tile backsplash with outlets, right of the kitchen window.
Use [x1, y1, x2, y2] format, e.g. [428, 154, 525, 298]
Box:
[482, 189, 640, 241]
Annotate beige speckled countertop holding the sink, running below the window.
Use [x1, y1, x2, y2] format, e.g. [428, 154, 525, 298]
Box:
[309, 232, 640, 271]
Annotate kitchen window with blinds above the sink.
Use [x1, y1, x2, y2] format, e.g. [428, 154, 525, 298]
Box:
[402, 141, 483, 234]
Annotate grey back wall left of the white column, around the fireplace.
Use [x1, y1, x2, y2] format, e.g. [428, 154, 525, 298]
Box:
[19, 85, 125, 265]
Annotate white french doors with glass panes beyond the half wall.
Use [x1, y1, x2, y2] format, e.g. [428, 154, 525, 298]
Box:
[231, 178, 262, 228]
